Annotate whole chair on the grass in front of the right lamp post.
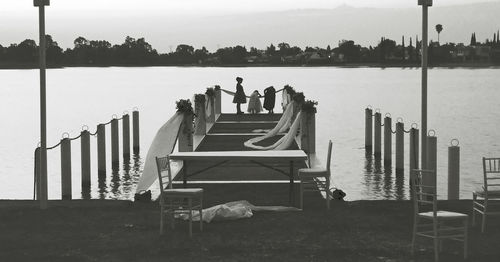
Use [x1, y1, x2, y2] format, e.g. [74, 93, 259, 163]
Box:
[411, 170, 469, 262]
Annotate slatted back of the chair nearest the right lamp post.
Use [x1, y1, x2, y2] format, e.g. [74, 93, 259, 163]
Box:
[412, 169, 437, 218]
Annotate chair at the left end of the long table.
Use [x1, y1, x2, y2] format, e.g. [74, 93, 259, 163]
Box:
[156, 156, 203, 237]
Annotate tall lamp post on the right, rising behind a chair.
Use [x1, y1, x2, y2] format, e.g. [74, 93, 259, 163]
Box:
[418, 0, 432, 169]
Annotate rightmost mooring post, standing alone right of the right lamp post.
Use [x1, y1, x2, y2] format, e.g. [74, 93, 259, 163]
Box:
[448, 139, 460, 200]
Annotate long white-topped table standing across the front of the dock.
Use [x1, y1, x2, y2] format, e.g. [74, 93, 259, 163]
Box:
[170, 150, 307, 204]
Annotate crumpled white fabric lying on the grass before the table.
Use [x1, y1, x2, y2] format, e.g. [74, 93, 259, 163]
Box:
[176, 200, 300, 223]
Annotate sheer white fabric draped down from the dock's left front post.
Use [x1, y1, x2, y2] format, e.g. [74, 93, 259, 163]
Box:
[136, 112, 184, 192]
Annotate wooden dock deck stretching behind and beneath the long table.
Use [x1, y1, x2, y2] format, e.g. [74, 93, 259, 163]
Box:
[177, 114, 321, 205]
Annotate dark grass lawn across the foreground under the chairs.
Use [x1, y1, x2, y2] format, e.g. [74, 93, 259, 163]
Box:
[0, 185, 500, 261]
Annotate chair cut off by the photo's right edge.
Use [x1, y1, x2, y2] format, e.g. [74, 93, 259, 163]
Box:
[472, 157, 500, 233]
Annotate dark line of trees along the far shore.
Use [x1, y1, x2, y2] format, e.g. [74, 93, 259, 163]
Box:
[0, 34, 500, 67]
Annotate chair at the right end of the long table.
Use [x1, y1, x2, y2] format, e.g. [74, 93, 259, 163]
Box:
[298, 140, 332, 209]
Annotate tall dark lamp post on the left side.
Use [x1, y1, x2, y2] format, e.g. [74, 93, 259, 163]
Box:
[33, 0, 50, 209]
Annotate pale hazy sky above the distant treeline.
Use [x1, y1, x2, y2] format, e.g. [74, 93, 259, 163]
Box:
[0, 0, 500, 52]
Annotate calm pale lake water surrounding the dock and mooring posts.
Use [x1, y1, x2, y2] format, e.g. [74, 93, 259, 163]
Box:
[0, 67, 500, 200]
